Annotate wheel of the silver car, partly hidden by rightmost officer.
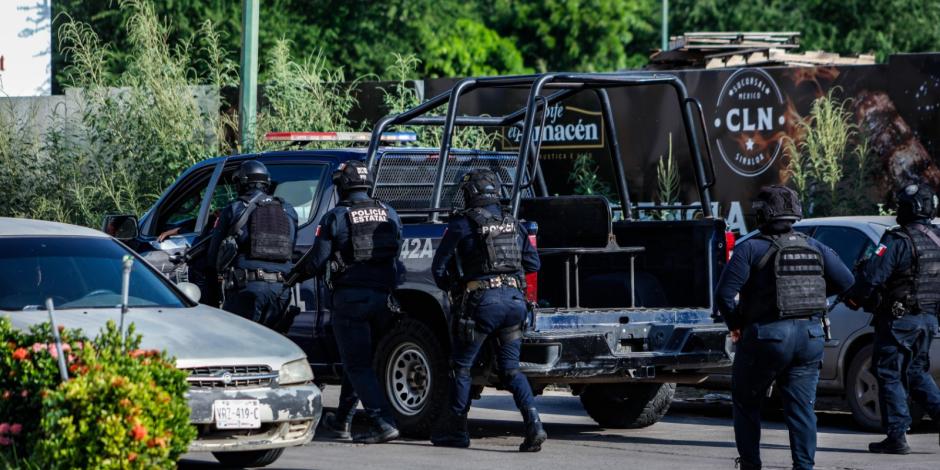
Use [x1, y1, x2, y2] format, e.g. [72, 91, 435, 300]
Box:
[845, 344, 925, 432]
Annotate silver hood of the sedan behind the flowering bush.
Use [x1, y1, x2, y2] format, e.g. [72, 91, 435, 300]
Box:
[0, 305, 304, 370]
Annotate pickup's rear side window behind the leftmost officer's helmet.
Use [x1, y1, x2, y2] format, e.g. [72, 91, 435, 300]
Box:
[209, 163, 326, 226]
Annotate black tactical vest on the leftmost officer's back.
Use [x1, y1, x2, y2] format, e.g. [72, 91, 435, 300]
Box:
[247, 197, 294, 263]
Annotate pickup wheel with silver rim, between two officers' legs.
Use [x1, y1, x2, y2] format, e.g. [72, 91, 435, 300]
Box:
[375, 318, 450, 439]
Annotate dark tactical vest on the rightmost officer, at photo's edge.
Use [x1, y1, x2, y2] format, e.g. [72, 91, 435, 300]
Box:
[885, 224, 940, 311]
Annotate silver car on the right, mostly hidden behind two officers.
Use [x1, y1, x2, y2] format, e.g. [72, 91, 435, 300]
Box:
[705, 216, 940, 431]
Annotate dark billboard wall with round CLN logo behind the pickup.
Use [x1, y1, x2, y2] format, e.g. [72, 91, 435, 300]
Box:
[425, 54, 940, 232]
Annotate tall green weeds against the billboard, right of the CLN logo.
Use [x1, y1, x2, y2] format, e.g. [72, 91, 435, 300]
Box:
[784, 88, 874, 217]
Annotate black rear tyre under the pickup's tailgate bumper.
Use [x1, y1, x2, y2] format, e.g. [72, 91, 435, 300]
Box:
[581, 383, 676, 429]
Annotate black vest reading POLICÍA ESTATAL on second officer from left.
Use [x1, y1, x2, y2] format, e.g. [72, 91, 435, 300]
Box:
[343, 199, 399, 263]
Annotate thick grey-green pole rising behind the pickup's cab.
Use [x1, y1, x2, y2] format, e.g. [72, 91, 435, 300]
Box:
[238, 0, 259, 153]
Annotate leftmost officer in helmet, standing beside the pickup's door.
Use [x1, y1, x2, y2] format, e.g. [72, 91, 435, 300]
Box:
[208, 160, 297, 328]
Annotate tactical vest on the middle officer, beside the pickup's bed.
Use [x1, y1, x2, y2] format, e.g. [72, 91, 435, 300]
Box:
[461, 208, 522, 277]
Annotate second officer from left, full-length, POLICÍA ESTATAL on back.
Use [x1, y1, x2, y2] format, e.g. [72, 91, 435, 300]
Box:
[306, 160, 401, 444]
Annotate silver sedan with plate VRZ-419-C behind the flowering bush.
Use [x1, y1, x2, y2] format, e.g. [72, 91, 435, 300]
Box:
[0, 218, 322, 466]
